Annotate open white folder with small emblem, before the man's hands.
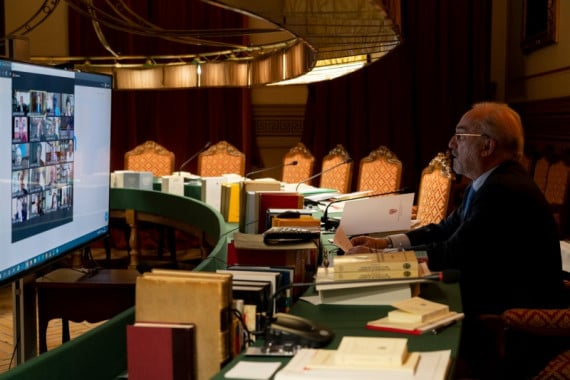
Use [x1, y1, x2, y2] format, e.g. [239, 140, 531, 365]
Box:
[340, 193, 414, 235]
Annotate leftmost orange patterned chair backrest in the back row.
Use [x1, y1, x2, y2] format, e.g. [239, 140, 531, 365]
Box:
[124, 140, 174, 177]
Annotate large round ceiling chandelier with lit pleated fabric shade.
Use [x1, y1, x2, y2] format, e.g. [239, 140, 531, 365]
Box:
[7, 0, 400, 89]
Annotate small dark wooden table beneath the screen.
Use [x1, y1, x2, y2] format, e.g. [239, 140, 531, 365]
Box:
[34, 268, 139, 353]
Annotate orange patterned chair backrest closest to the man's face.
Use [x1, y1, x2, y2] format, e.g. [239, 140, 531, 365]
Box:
[416, 153, 455, 227]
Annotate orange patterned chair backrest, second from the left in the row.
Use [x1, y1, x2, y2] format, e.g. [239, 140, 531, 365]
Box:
[198, 140, 245, 177]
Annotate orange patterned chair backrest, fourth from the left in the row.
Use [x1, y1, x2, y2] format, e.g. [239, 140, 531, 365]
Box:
[319, 144, 352, 193]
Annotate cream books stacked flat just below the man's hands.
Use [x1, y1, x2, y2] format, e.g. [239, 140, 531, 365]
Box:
[334, 251, 418, 277]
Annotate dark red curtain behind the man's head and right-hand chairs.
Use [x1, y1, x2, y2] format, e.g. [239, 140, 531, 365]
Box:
[302, 0, 491, 189]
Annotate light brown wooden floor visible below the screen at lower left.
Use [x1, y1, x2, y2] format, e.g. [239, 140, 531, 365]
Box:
[0, 285, 103, 373]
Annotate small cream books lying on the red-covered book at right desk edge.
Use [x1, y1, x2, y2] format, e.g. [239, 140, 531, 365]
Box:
[388, 297, 449, 322]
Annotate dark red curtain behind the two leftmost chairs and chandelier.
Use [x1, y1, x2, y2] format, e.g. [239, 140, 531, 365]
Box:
[69, 0, 254, 173]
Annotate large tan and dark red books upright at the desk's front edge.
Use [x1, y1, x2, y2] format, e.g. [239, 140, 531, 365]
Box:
[127, 269, 233, 380]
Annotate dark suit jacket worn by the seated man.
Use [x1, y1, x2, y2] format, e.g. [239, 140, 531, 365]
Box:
[407, 161, 562, 315]
